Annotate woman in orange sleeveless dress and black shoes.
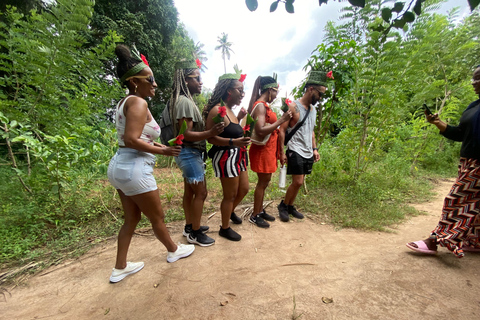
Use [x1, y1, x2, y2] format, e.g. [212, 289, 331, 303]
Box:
[248, 76, 292, 228]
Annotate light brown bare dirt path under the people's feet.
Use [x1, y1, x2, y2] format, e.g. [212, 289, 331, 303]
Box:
[0, 181, 480, 319]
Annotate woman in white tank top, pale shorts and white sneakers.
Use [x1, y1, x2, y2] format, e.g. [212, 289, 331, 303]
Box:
[108, 45, 195, 282]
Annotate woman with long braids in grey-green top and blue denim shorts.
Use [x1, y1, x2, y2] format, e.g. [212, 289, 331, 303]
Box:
[169, 59, 224, 247]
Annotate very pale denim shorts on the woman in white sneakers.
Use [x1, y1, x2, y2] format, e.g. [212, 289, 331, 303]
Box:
[107, 148, 158, 196]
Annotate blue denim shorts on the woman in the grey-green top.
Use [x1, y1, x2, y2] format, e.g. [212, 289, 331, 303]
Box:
[175, 147, 205, 184]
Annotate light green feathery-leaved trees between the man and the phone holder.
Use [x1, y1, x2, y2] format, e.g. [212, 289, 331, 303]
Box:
[300, 3, 480, 180]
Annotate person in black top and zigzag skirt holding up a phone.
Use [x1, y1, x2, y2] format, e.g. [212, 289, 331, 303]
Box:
[407, 66, 480, 258]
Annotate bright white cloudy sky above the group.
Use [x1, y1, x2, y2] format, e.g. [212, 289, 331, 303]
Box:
[174, 0, 470, 107]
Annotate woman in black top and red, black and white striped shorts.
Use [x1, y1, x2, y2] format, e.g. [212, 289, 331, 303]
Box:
[203, 68, 250, 241]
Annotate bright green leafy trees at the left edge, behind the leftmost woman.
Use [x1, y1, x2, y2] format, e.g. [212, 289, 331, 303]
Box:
[0, 0, 121, 199]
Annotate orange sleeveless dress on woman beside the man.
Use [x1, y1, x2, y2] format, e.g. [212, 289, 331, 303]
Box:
[248, 101, 278, 173]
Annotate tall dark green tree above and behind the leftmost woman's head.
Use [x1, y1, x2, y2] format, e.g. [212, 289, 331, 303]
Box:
[87, 0, 194, 105]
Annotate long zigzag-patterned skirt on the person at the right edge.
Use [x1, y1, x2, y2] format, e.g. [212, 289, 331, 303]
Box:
[432, 158, 480, 258]
